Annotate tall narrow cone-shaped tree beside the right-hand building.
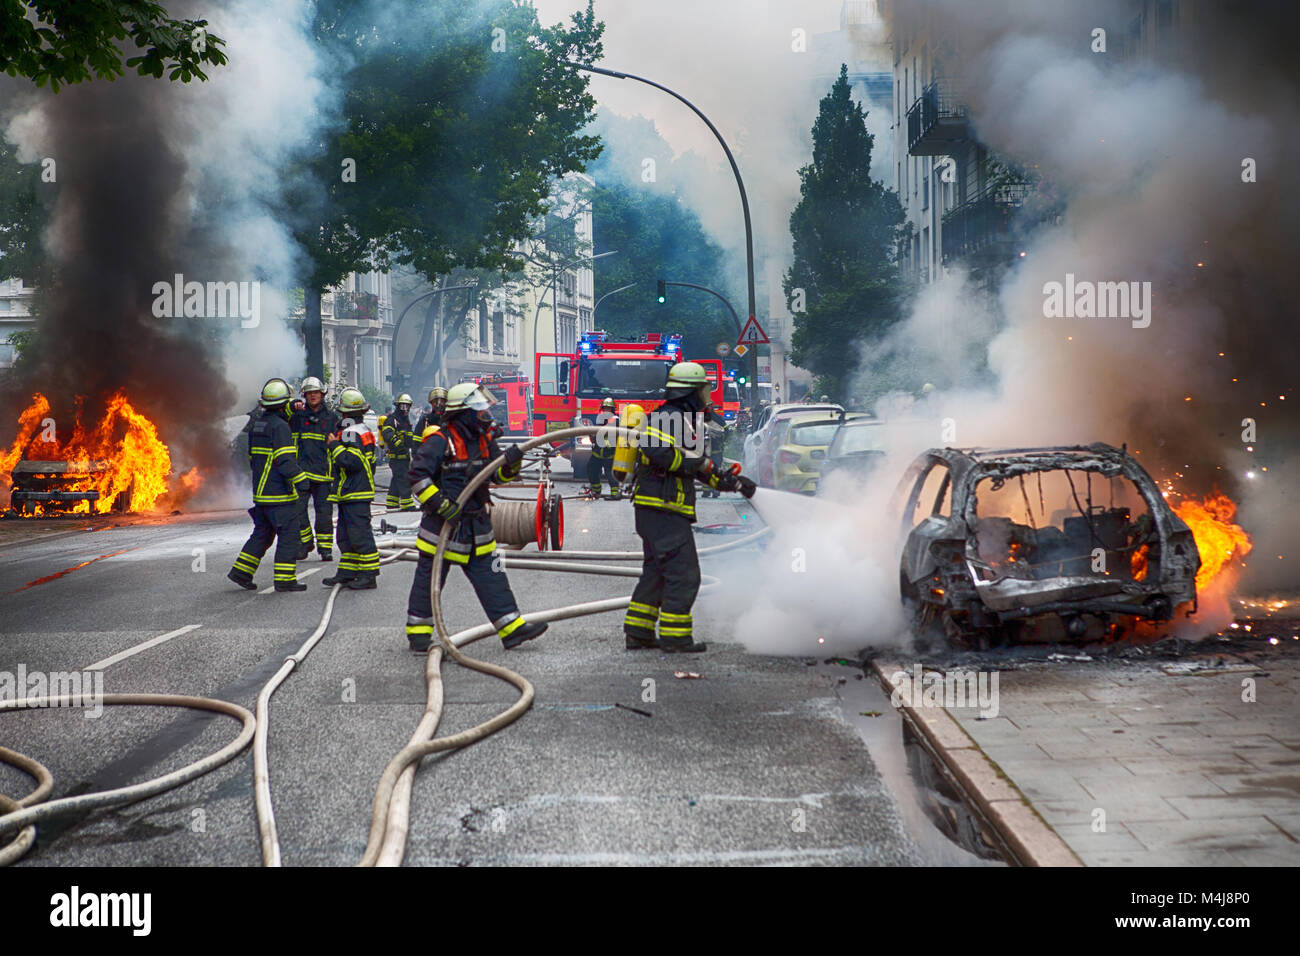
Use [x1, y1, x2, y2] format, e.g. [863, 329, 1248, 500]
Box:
[784, 65, 907, 398]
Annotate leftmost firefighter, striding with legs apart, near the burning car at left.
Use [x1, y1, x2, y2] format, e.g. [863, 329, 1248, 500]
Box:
[226, 378, 311, 591]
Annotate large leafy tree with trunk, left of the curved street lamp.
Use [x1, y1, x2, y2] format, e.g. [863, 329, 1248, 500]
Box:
[282, 0, 603, 377]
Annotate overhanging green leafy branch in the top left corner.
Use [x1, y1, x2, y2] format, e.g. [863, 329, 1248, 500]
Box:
[0, 0, 226, 91]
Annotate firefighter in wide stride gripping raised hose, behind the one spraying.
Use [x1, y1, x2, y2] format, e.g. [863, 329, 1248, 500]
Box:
[406, 382, 546, 653]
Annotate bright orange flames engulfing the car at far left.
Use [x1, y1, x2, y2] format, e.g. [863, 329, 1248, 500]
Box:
[0, 392, 183, 514]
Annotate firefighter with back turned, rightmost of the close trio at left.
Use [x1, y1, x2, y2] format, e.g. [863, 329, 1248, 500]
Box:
[321, 389, 380, 591]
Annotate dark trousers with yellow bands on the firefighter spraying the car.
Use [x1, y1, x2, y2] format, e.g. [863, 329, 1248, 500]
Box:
[623, 506, 699, 644]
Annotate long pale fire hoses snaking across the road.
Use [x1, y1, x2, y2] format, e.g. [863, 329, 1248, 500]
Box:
[0, 425, 767, 866]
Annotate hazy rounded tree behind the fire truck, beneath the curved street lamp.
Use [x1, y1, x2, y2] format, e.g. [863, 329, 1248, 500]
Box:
[592, 181, 737, 358]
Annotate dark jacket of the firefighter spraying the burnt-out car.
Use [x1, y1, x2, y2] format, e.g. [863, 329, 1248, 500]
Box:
[632, 402, 718, 522]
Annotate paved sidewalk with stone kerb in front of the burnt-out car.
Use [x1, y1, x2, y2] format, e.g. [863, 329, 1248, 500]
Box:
[875, 627, 1300, 866]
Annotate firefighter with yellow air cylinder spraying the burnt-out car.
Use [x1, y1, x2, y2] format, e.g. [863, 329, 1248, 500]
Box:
[623, 362, 755, 654]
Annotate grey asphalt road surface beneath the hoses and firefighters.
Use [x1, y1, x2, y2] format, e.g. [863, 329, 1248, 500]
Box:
[0, 470, 975, 866]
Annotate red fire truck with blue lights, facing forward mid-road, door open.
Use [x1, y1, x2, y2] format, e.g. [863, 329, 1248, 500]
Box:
[533, 332, 724, 479]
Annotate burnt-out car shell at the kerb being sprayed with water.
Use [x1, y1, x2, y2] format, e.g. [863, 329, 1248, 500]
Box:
[894, 444, 1201, 649]
